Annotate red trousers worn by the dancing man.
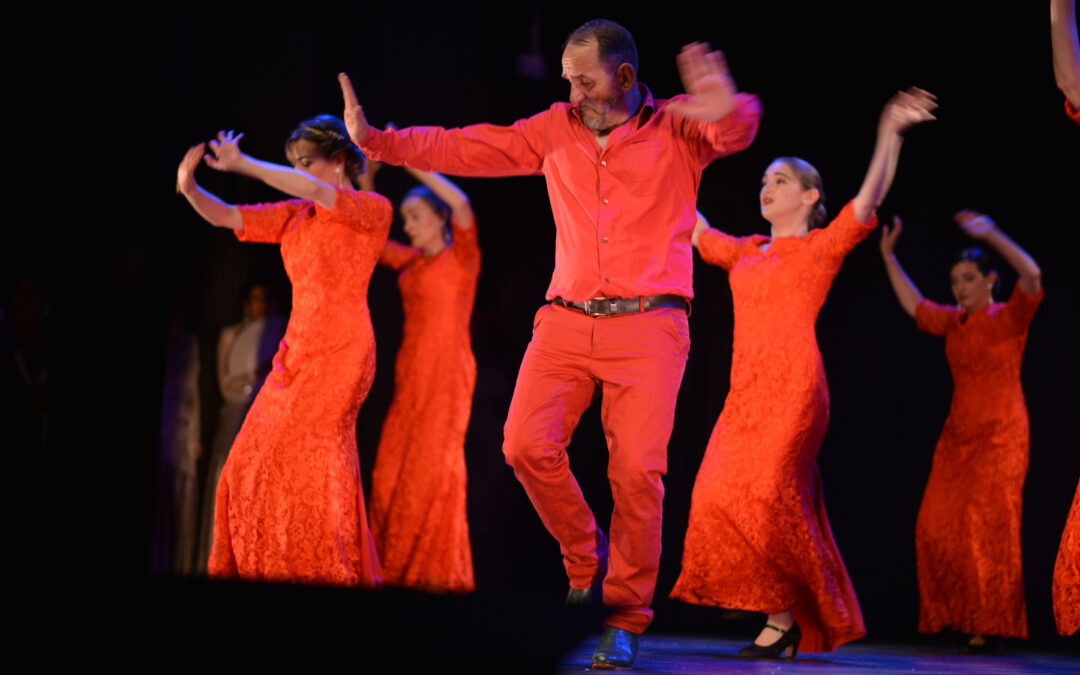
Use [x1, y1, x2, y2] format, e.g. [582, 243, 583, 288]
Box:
[502, 305, 690, 633]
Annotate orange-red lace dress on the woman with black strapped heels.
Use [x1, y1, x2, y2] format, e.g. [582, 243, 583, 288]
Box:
[672, 199, 877, 651]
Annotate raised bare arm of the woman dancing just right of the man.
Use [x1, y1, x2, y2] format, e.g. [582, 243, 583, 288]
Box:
[853, 86, 937, 222]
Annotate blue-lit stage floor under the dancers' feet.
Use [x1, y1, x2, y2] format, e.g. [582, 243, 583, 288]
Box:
[556, 633, 1080, 675]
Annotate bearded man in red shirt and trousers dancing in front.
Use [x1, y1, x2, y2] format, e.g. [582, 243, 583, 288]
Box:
[339, 19, 761, 667]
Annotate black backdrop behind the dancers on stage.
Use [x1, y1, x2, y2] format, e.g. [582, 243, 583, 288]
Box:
[21, 1, 1080, 646]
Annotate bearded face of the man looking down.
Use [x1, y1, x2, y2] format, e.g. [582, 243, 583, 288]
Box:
[563, 40, 633, 133]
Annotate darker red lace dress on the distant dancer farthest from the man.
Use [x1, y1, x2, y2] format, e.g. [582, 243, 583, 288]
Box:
[915, 285, 1042, 637]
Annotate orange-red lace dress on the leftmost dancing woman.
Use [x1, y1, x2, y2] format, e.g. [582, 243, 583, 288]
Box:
[208, 185, 393, 586]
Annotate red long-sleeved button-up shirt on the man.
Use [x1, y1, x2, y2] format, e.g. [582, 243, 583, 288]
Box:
[360, 85, 761, 302]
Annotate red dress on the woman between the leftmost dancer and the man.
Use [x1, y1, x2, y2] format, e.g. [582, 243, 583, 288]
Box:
[369, 221, 480, 592]
